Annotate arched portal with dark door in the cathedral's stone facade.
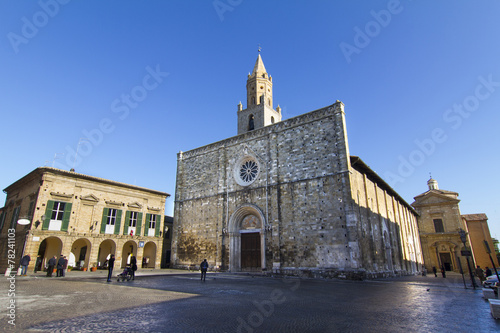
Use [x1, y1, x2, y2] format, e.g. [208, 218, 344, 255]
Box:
[229, 204, 266, 272]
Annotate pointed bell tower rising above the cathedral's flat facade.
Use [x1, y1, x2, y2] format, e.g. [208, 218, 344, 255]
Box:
[238, 50, 281, 134]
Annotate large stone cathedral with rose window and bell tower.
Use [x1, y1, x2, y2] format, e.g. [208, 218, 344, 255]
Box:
[172, 54, 422, 279]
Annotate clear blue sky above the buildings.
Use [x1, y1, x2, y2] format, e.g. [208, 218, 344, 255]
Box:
[0, 0, 500, 238]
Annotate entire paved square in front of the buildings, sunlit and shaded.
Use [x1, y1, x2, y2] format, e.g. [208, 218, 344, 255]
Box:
[0, 273, 500, 332]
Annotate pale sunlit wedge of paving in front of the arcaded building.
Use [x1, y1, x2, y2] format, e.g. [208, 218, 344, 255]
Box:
[0, 278, 197, 332]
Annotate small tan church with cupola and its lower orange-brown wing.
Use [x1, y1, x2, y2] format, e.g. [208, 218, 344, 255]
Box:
[412, 178, 498, 272]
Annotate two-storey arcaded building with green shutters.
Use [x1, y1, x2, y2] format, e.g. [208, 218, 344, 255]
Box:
[0, 167, 169, 271]
